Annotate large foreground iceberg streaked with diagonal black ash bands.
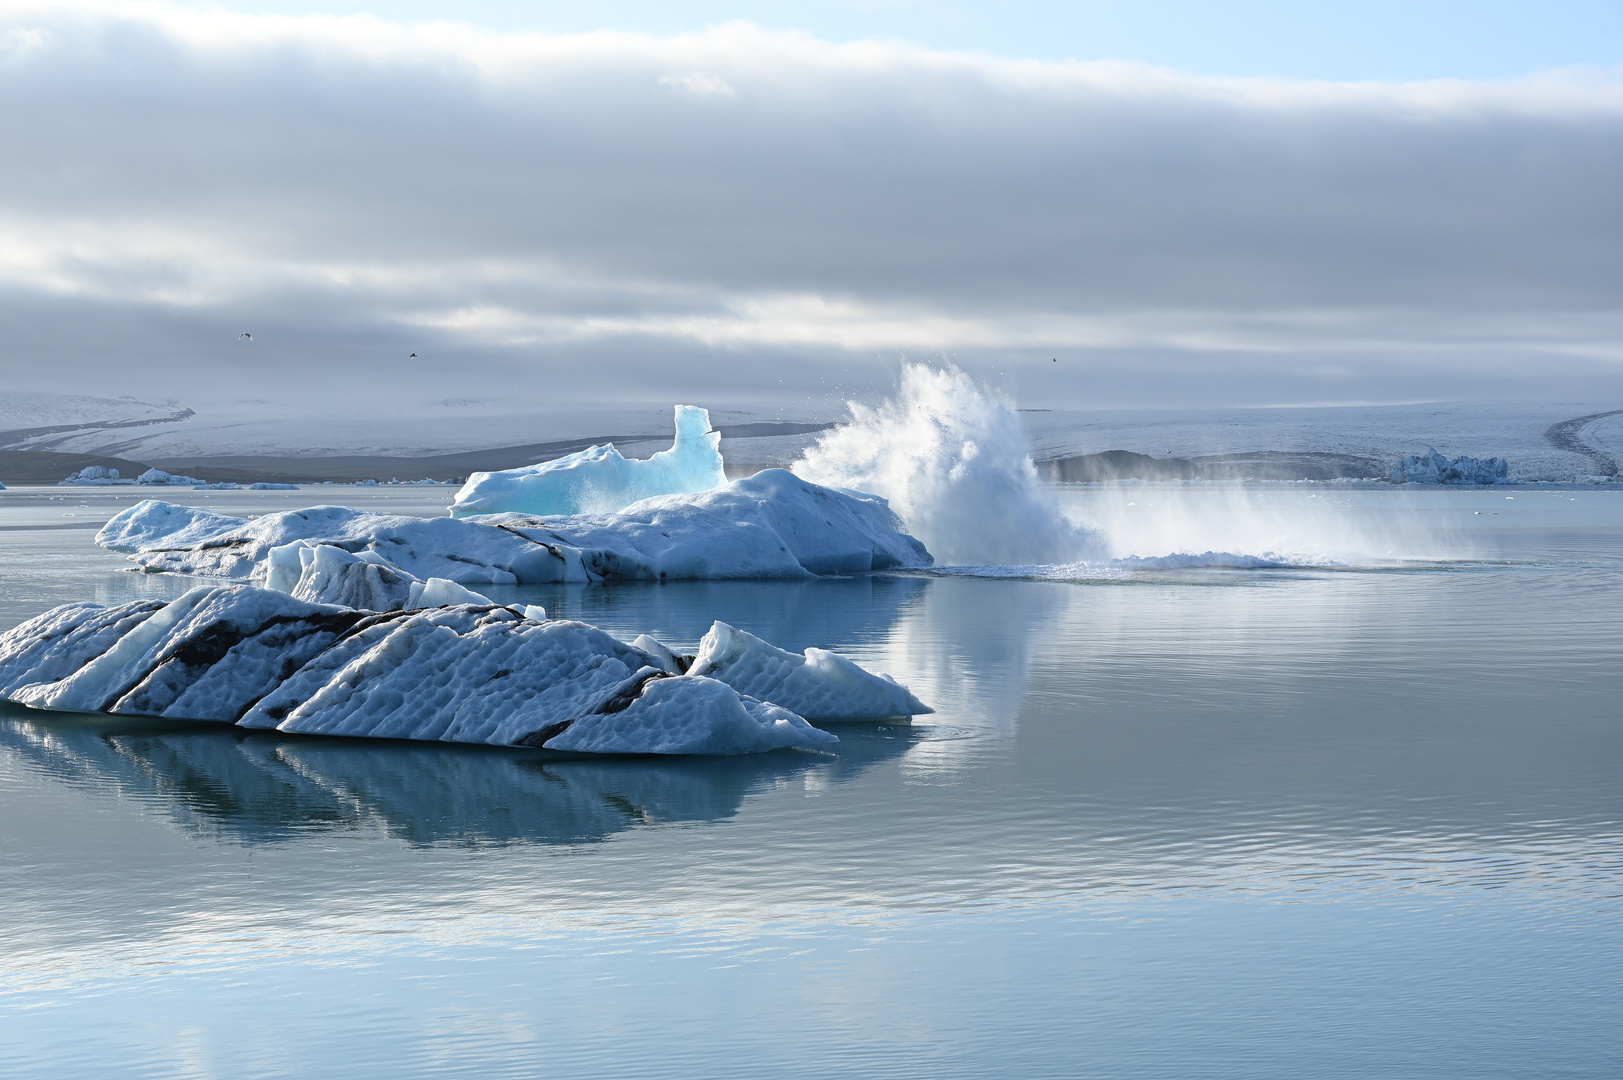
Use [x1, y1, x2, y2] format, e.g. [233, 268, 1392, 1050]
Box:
[0, 585, 837, 754]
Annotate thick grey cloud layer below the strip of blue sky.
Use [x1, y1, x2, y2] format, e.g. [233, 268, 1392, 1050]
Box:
[0, 6, 1623, 410]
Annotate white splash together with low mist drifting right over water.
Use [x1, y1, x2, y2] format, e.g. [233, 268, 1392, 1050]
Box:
[794, 364, 1469, 577]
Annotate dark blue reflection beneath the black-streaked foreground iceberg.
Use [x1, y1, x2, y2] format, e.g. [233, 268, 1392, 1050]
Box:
[0, 703, 914, 845]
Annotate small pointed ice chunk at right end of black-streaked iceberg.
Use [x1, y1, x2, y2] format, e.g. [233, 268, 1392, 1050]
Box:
[691, 622, 935, 719]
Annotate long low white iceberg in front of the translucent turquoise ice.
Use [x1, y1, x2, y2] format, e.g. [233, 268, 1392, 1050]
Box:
[96, 469, 933, 585]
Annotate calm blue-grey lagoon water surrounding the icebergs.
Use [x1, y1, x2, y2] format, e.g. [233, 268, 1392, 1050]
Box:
[0, 489, 1623, 1077]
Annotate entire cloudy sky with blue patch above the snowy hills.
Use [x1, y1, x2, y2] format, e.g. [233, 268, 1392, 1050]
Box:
[0, 0, 1623, 421]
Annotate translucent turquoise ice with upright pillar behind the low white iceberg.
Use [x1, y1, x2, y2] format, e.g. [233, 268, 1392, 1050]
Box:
[451, 404, 727, 518]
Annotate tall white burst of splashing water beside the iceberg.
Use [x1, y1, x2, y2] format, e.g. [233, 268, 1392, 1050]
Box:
[792, 364, 1105, 565]
